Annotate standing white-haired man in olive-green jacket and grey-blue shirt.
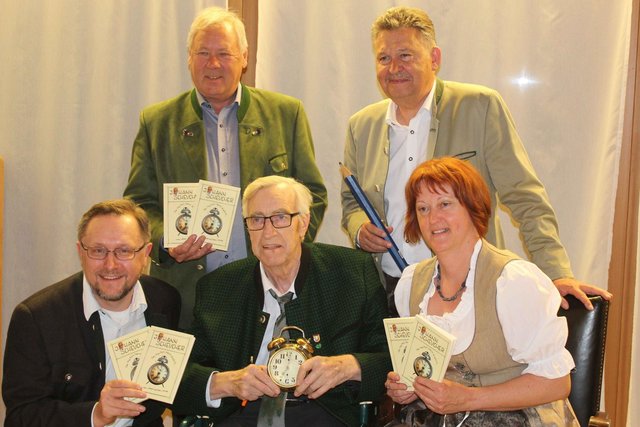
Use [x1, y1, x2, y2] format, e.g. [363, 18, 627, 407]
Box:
[124, 7, 327, 328]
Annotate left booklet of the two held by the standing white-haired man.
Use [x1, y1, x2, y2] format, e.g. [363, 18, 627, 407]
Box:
[163, 183, 200, 248]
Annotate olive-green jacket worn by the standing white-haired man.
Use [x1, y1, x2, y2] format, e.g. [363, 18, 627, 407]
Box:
[124, 86, 327, 328]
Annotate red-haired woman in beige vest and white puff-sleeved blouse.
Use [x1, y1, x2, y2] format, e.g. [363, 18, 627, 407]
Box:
[385, 157, 578, 426]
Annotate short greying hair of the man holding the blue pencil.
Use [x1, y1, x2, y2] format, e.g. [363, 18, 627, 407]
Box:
[371, 6, 436, 49]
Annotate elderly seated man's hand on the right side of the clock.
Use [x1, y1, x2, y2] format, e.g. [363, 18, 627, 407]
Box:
[294, 354, 362, 399]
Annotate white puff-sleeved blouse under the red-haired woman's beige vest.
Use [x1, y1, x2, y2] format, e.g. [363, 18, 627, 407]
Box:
[395, 240, 575, 379]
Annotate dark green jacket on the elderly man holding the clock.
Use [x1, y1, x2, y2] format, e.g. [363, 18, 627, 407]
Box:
[173, 243, 392, 426]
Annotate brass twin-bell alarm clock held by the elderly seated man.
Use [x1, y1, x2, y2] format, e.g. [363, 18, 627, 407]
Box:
[267, 326, 313, 391]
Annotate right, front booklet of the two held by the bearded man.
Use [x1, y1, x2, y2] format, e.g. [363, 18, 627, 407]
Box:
[134, 326, 195, 404]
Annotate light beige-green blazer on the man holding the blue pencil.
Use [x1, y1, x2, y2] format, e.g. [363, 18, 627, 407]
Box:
[342, 79, 573, 279]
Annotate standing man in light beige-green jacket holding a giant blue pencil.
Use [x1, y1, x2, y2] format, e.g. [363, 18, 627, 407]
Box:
[342, 7, 611, 312]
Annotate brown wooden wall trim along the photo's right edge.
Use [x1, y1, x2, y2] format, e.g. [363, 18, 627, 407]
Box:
[605, 0, 640, 426]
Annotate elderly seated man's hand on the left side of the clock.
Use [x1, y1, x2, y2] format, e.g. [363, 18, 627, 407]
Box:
[209, 365, 280, 401]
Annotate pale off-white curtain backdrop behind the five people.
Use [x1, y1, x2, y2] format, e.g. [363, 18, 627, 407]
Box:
[0, 0, 633, 421]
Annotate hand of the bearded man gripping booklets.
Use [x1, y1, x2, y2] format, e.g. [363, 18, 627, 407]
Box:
[93, 380, 147, 427]
